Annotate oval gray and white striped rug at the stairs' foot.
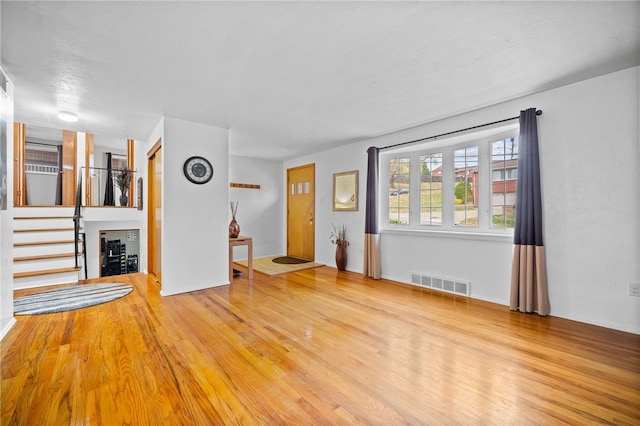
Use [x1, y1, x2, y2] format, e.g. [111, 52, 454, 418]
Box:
[13, 283, 133, 315]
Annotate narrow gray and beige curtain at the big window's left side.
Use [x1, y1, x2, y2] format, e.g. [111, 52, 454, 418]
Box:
[364, 146, 380, 279]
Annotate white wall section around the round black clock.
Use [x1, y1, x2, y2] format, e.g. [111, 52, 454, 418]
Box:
[160, 117, 229, 296]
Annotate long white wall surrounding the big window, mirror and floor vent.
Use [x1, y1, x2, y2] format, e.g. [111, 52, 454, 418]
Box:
[283, 67, 640, 333]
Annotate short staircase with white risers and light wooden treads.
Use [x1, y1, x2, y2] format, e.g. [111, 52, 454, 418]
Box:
[13, 206, 82, 289]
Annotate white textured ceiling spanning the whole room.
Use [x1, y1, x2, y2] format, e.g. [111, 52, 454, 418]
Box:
[0, 0, 640, 159]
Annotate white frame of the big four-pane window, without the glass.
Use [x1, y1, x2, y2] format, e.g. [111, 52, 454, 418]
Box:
[379, 124, 519, 236]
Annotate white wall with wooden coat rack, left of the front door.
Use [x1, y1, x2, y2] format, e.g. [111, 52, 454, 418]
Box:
[227, 156, 285, 260]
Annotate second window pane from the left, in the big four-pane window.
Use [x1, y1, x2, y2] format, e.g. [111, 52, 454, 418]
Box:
[420, 152, 442, 225]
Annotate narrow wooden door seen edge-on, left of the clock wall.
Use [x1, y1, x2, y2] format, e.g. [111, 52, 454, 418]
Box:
[147, 140, 162, 283]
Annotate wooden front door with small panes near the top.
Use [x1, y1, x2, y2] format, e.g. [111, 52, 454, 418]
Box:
[287, 164, 316, 260]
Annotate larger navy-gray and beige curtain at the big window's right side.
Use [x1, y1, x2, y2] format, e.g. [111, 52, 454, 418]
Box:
[510, 108, 551, 315]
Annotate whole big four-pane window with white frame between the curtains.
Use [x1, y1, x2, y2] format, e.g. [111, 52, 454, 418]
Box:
[381, 125, 518, 233]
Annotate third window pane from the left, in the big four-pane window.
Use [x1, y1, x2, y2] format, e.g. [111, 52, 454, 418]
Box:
[453, 146, 478, 227]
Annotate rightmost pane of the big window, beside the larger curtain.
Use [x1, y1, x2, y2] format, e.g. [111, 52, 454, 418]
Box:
[491, 137, 518, 228]
